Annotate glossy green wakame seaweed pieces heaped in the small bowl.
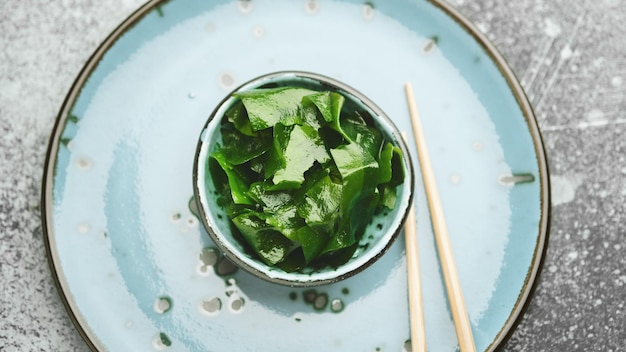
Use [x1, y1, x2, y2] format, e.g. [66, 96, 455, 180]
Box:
[207, 87, 405, 271]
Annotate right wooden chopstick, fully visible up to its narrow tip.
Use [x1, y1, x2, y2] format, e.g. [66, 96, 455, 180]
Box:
[405, 82, 476, 352]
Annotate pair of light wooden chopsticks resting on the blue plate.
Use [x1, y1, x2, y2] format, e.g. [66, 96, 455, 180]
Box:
[405, 82, 476, 352]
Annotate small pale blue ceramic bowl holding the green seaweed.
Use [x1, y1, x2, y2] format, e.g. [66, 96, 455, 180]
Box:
[193, 71, 414, 286]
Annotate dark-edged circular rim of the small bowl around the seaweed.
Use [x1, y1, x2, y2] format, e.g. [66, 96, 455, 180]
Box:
[193, 71, 415, 287]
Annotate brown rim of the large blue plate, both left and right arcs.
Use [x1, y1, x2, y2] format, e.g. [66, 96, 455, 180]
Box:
[40, 0, 552, 352]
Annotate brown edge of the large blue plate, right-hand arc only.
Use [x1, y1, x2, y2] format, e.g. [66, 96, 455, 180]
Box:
[427, 0, 552, 352]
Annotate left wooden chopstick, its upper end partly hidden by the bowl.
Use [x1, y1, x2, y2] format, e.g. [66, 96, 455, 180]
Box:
[402, 132, 426, 352]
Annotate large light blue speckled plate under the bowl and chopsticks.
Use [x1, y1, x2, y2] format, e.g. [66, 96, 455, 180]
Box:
[42, 0, 549, 351]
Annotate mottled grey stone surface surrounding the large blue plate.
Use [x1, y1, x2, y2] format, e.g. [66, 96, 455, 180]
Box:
[0, 0, 626, 352]
